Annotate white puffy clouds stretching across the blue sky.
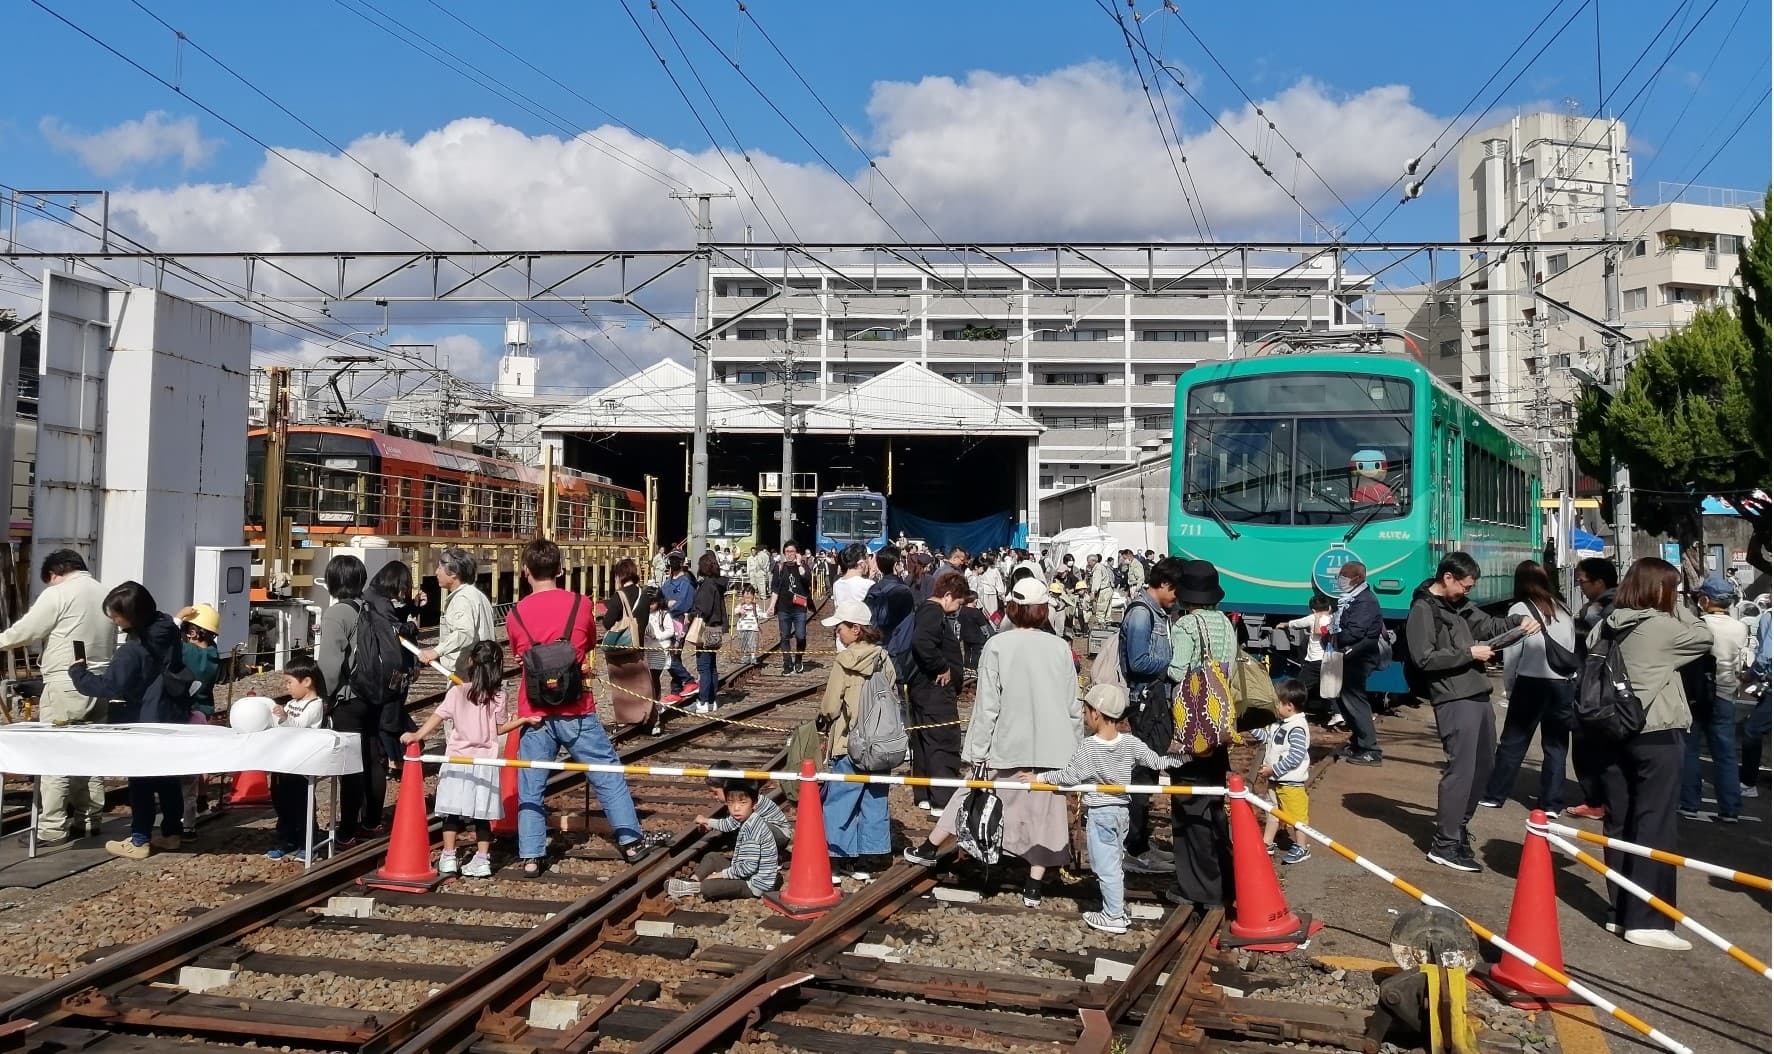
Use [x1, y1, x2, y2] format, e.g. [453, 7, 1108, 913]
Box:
[17, 64, 1451, 385]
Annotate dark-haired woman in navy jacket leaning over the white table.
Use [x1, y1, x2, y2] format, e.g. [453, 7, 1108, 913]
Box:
[67, 582, 192, 861]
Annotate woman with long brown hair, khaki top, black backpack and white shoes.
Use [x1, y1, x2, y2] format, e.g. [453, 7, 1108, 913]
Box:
[1582, 557, 1712, 951]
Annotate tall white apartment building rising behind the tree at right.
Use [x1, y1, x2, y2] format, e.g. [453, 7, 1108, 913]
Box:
[1447, 114, 1762, 416]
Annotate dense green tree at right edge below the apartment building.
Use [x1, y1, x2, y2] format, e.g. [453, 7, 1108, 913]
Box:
[1575, 299, 1769, 570]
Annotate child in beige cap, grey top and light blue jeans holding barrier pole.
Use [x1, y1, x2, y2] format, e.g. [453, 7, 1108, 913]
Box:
[1034, 685, 1181, 933]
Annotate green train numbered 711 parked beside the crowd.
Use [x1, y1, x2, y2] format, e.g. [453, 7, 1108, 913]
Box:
[1169, 351, 1542, 674]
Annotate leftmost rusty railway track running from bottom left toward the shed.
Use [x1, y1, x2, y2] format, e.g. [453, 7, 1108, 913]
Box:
[0, 613, 823, 1050]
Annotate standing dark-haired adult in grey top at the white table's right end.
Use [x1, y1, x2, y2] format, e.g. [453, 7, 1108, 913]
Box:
[314, 554, 392, 850]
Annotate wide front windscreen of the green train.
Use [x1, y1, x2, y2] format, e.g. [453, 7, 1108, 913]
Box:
[1183, 373, 1412, 527]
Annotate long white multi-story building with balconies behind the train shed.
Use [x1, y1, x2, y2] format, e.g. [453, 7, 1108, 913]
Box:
[710, 257, 1366, 493]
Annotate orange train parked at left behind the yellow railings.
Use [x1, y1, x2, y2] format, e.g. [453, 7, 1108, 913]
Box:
[247, 424, 648, 543]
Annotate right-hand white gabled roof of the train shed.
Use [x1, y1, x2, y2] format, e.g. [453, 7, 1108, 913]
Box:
[807, 362, 1041, 437]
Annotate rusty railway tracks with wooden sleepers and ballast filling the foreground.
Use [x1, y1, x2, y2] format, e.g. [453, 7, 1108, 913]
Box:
[0, 599, 1378, 1054]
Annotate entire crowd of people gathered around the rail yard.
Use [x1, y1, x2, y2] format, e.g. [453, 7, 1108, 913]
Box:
[0, 528, 1770, 949]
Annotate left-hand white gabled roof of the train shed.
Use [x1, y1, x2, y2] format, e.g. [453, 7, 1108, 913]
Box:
[541, 358, 782, 431]
